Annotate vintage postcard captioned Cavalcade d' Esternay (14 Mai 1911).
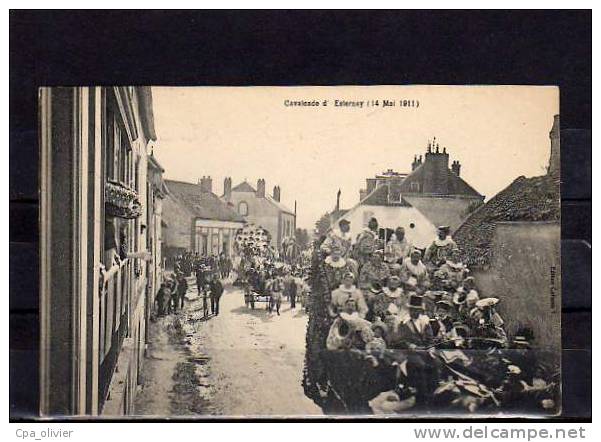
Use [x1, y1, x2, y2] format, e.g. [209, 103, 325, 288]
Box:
[39, 86, 561, 419]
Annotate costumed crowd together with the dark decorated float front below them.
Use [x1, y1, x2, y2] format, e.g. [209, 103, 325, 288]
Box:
[310, 218, 557, 413]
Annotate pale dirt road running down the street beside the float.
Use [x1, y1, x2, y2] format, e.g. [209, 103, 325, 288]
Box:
[136, 283, 321, 416]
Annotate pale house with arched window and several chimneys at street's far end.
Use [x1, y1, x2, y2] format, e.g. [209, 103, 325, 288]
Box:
[221, 177, 296, 250]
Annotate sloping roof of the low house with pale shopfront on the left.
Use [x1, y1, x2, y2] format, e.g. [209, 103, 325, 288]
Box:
[165, 180, 244, 222]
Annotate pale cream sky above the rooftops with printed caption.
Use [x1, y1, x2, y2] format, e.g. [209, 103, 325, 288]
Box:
[152, 86, 559, 229]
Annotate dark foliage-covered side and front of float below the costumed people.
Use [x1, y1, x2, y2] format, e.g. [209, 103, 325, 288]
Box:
[303, 247, 561, 416]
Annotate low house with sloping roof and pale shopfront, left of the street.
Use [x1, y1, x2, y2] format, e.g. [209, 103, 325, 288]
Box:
[163, 177, 245, 258]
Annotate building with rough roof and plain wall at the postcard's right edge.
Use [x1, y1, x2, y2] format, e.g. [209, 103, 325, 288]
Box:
[454, 116, 561, 352]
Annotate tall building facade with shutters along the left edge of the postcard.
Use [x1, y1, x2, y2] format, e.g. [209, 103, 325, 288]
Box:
[40, 87, 162, 415]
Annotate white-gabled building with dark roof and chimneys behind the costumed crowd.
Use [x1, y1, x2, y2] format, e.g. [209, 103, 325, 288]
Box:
[335, 143, 484, 248]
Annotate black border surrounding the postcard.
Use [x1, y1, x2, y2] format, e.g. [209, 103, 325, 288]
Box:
[9, 10, 592, 422]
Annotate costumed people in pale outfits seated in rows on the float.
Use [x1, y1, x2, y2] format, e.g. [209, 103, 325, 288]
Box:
[320, 218, 508, 350]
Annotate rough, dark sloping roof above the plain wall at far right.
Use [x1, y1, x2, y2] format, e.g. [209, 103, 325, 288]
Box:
[453, 175, 561, 266]
